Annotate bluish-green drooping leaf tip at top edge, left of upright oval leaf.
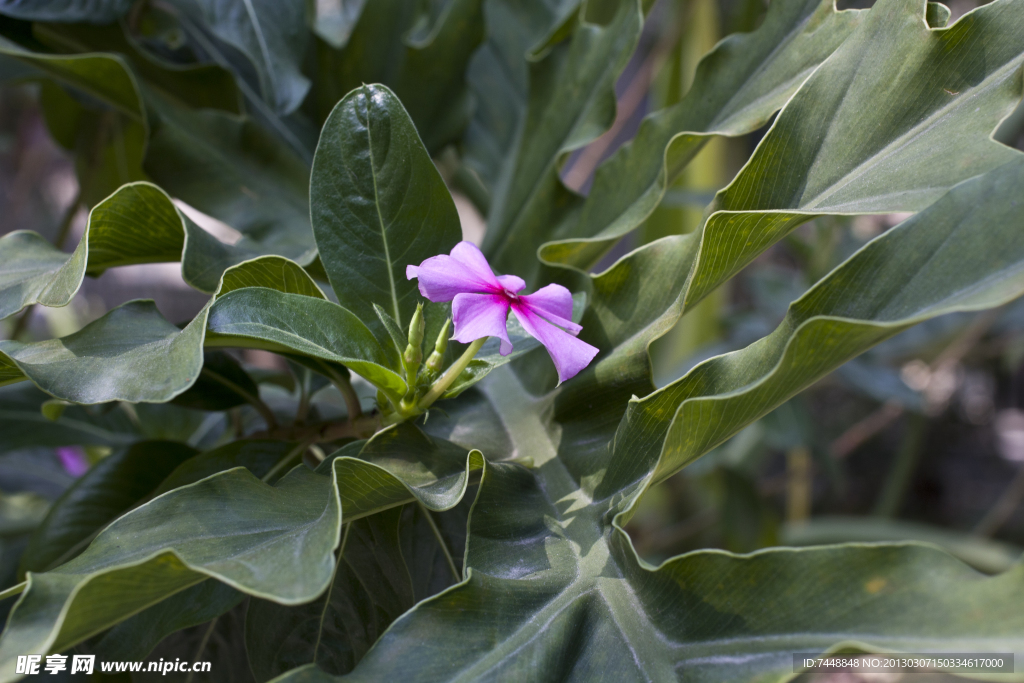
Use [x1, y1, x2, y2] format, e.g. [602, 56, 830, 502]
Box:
[165, 0, 309, 114]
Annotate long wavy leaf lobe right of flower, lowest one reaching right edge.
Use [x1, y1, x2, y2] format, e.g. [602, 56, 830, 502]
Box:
[615, 159, 1024, 489]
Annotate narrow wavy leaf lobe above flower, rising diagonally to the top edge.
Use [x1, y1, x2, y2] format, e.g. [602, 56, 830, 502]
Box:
[540, 0, 864, 269]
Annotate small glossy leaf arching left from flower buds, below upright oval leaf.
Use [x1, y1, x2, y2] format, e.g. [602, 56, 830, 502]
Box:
[203, 287, 408, 396]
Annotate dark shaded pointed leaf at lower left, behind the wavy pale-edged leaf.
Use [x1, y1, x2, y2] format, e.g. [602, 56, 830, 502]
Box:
[18, 441, 197, 575]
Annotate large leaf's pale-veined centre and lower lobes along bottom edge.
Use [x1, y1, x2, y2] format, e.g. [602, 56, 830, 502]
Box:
[278, 371, 1024, 682]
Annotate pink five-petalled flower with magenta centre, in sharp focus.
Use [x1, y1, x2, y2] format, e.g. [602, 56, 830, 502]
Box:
[406, 242, 597, 383]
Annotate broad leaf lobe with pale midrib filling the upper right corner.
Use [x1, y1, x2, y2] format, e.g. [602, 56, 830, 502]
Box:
[685, 0, 1024, 306]
